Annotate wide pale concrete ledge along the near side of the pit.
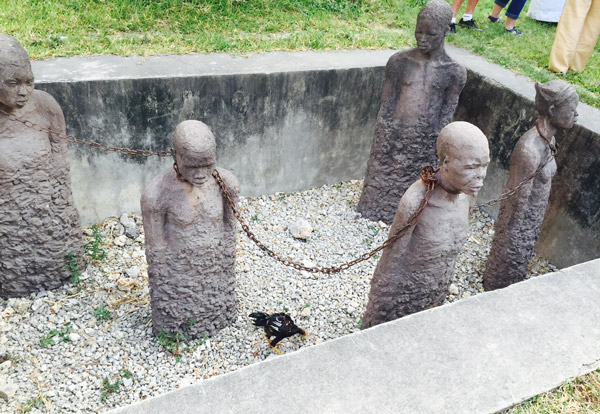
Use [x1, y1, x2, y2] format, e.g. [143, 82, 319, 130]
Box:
[112, 260, 600, 414]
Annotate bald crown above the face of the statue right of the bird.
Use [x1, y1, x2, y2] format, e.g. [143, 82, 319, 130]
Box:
[436, 121, 489, 163]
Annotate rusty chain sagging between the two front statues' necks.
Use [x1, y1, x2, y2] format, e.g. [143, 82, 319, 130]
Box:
[213, 166, 437, 274]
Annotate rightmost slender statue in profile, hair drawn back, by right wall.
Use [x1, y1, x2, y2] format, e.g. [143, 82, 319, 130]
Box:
[483, 80, 579, 290]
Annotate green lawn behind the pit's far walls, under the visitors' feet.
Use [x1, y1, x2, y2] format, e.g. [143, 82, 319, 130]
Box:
[0, 0, 600, 108]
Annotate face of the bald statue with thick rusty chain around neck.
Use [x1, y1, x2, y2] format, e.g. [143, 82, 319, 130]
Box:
[442, 145, 490, 196]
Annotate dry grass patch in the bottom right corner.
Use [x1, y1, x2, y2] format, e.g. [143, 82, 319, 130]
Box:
[509, 369, 600, 414]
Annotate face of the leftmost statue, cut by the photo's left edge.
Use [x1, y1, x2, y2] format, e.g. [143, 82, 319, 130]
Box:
[0, 65, 33, 111]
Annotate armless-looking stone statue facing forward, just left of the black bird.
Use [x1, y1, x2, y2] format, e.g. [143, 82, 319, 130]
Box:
[142, 121, 239, 338]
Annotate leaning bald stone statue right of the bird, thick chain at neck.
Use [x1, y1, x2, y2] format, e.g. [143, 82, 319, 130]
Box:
[362, 122, 490, 329]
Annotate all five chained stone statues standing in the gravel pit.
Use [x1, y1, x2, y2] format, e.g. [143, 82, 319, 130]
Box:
[0, 0, 578, 337]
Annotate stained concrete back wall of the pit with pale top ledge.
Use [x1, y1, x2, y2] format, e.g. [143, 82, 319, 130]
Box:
[34, 51, 390, 224]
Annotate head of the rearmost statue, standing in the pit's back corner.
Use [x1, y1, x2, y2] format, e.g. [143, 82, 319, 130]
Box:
[415, 0, 452, 54]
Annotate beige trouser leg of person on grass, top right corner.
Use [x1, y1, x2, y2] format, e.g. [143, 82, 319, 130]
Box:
[548, 0, 592, 73]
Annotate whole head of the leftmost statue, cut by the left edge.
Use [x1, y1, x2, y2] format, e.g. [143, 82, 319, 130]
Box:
[0, 34, 34, 112]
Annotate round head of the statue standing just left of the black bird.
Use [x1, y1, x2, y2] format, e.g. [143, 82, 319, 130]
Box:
[173, 121, 217, 187]
